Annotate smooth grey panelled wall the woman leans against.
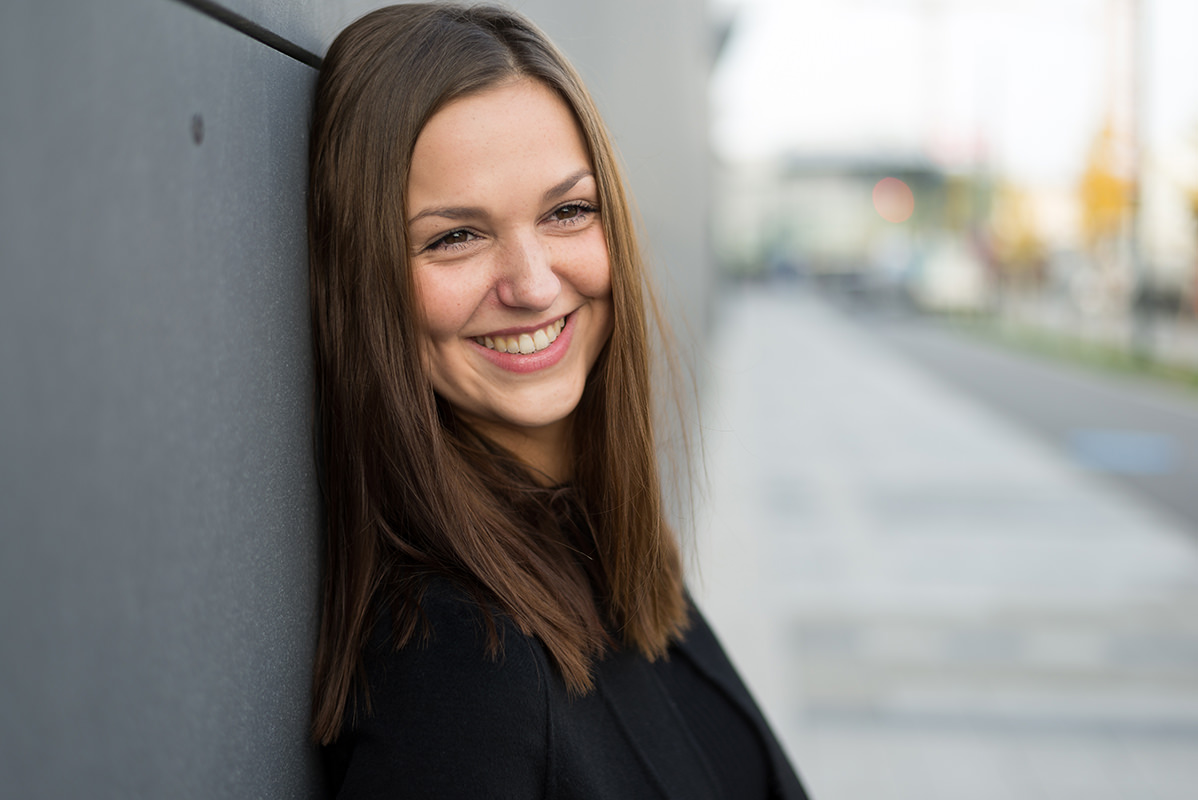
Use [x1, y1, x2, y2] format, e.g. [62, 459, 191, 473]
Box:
[0, 0, 708, 798]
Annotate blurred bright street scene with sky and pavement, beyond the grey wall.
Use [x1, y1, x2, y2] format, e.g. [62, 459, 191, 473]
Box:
[695, 0, 1198, 800]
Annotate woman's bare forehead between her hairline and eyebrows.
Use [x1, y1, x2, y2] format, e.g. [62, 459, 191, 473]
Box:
[409, 79, 591, 205]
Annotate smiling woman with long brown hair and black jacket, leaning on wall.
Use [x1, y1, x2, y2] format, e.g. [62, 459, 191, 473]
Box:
[309, 5, 804, 799]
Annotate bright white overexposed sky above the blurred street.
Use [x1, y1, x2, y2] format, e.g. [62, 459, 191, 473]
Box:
[712, 0, 1198, 182]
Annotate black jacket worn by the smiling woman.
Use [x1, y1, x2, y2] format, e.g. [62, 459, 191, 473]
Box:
[326, 587, 806, 800]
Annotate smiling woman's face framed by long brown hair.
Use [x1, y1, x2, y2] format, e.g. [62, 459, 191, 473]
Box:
[407, 80, 612, 451]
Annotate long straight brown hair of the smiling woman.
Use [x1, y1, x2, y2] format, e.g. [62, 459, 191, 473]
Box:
[308, 4, 685, 744]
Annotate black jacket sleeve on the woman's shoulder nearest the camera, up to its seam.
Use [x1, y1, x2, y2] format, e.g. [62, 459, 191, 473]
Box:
[328, 582, 551, 798]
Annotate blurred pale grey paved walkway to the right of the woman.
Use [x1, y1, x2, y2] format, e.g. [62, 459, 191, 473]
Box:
[692, 286, 1198, 800]
